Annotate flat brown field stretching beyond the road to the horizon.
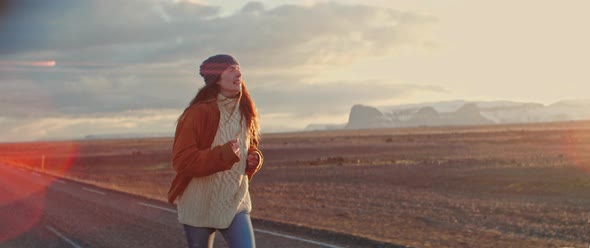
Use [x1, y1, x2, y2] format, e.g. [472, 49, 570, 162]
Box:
[0, 122, 590, 247]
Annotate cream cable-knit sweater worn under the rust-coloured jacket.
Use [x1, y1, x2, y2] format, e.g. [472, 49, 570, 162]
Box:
[177, 95, 252, 229]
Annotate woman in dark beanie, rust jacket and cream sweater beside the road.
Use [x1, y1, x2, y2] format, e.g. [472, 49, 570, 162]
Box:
[168, 54, 263, 247]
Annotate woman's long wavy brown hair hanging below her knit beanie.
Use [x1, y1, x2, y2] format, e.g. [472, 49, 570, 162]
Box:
[177, 83, 260, 146]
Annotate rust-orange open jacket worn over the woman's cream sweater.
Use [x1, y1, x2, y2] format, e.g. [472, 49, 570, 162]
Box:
[168, 99, 264, 203]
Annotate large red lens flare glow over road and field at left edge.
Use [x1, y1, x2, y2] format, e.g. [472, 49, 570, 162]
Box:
[0, 141, 78, 243]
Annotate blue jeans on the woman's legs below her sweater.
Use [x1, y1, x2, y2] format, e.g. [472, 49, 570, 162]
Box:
[183, 212, 256, 248]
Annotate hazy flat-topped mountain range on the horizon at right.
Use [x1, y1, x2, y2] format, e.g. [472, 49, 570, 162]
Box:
[306, 99, 590, 130]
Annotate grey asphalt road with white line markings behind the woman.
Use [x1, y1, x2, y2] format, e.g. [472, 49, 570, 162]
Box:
[0, 164, 364, 248]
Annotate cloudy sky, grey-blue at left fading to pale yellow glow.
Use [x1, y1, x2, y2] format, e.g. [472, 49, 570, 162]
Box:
[0, 0, 590, 142]
